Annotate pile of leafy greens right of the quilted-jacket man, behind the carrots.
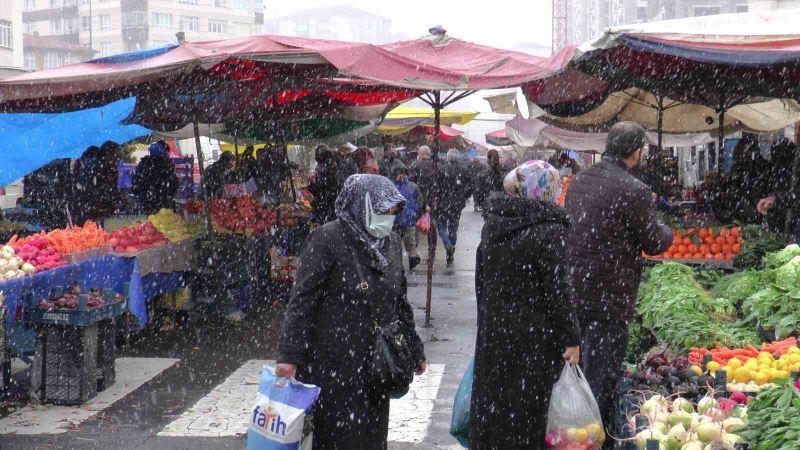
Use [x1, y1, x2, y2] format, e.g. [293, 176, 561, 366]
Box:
[637, 262, 760, 353]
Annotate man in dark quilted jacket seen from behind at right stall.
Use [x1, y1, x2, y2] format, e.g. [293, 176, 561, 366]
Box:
[566, 122, 672, 442]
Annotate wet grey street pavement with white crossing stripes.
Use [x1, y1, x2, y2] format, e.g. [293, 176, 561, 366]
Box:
[0, 206, 483, 450]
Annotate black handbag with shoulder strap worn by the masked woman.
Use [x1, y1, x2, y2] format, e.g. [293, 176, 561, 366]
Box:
[345, 237, 416, 398]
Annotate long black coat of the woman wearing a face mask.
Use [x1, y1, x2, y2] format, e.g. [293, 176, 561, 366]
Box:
[278, 220, 425, 450]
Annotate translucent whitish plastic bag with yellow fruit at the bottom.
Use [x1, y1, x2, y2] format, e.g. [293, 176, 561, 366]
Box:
[545, 364, 606, 450]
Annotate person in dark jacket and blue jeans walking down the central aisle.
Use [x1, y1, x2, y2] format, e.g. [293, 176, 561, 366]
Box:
[436, 149, 472, 263]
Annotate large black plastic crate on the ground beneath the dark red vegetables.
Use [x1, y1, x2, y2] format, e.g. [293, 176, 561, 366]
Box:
[30, 324, 98, 406]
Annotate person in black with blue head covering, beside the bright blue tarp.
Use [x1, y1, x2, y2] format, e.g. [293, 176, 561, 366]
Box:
[131, 141, 178, 214]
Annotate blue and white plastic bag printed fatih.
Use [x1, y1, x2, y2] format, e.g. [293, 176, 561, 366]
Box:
[247, 366, 320, 450]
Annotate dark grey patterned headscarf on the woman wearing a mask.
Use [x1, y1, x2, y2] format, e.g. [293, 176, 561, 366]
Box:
[336, 174, 406, 270]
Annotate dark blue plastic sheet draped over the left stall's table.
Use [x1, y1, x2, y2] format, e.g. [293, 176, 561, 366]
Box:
[0, 255, 184, 353]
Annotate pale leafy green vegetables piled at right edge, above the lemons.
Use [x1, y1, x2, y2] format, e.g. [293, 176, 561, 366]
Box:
[742, 250, 800, 339]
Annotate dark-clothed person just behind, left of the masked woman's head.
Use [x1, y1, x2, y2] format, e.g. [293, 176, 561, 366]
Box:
[308, 145, 341, 225]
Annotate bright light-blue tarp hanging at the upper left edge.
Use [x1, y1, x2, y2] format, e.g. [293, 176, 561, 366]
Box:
[0, 97, 150, 186]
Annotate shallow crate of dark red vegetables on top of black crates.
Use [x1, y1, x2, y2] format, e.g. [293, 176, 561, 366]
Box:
[28, 288, 128, 327]
